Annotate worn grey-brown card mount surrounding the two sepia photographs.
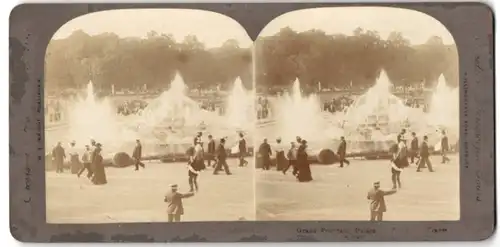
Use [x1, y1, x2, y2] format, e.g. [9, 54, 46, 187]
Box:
[9, 0, 496, 242]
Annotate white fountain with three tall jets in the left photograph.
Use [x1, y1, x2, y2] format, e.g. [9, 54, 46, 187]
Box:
[46, 74, 253, 166]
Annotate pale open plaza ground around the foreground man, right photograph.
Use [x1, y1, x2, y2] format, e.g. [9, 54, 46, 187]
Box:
[256, 155, 460, 221]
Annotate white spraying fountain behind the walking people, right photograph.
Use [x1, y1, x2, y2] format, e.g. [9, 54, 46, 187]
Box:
[257, 71, 458, 164]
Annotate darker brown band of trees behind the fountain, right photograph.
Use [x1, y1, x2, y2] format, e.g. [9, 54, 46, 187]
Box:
[256, 28, 458, 88]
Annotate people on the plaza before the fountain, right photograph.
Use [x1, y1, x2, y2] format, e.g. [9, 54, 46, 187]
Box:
[256, 126, 450, 221]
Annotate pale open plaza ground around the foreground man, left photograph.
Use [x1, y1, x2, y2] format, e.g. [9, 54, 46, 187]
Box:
[46, 159, 255, 223]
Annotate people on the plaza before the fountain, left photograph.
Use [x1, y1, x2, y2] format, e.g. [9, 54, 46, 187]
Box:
[51, 129, 248, 222]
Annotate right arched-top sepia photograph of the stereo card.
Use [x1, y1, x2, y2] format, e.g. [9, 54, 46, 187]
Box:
[253, 7, 460, 221]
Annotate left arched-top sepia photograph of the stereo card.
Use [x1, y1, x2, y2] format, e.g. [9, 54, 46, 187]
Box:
[44, 9, 255, 223]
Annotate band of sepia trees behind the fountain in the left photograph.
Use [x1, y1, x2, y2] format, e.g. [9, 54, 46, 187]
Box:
[45, 30, 252, 90]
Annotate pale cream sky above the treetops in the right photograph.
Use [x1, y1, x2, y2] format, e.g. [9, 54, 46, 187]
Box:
[260, 7, 455, 45]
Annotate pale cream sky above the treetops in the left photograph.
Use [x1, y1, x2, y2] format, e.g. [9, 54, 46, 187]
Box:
[52, 9, 252, 48]
